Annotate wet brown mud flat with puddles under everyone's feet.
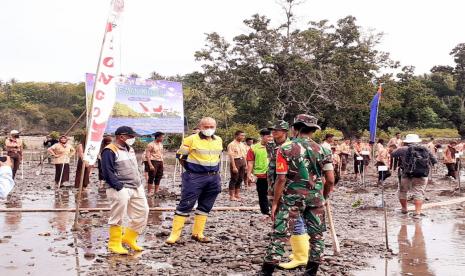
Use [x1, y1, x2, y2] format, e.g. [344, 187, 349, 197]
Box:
[0, 158, 465, 275]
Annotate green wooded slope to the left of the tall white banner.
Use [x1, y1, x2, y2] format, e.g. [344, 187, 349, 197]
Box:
[0, 79, 85, 134]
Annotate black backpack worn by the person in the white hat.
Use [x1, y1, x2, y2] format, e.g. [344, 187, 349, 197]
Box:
[403, 145, 431, 177]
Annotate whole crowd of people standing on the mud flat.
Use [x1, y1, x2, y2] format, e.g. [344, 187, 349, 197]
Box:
[0, 121, 464, 275]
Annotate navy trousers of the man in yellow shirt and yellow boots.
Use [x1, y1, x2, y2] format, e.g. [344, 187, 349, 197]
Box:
[176, 172, 221, 216]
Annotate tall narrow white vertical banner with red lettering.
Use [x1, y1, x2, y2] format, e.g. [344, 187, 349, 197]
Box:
[84, 0, 124, 165]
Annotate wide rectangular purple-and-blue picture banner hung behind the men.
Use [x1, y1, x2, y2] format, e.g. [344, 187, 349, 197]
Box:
[86, 73, 184, 135]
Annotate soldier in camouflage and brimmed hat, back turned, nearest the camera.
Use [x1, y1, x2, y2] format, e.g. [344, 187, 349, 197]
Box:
[260, 114, 334, 276]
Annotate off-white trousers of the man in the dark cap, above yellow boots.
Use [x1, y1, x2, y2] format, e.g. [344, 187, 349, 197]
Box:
[106, 185, 149, 234]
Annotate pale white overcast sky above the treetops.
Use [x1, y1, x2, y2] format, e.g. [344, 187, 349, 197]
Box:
[0, 0, 465, 82]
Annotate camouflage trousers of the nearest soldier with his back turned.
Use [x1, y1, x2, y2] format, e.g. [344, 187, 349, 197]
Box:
[264, 194, 326, 264]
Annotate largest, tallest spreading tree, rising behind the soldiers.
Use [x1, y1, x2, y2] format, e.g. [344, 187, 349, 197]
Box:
[188, 1, 397, 135]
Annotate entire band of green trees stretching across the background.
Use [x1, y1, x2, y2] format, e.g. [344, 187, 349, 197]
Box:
[0, 0, 465, 139]
